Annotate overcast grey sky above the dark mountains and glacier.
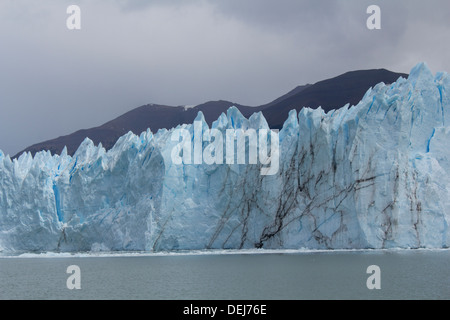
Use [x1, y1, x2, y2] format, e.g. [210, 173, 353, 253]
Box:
[0, 0, 450, 155]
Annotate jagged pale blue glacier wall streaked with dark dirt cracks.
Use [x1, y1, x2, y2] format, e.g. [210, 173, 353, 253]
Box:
[0, 63, 450, 253]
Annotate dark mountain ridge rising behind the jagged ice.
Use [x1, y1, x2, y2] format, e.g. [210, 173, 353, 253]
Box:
[14, 69, 408, 158]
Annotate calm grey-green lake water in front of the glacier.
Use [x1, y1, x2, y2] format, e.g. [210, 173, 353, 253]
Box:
[0, 250, 450, 300]
